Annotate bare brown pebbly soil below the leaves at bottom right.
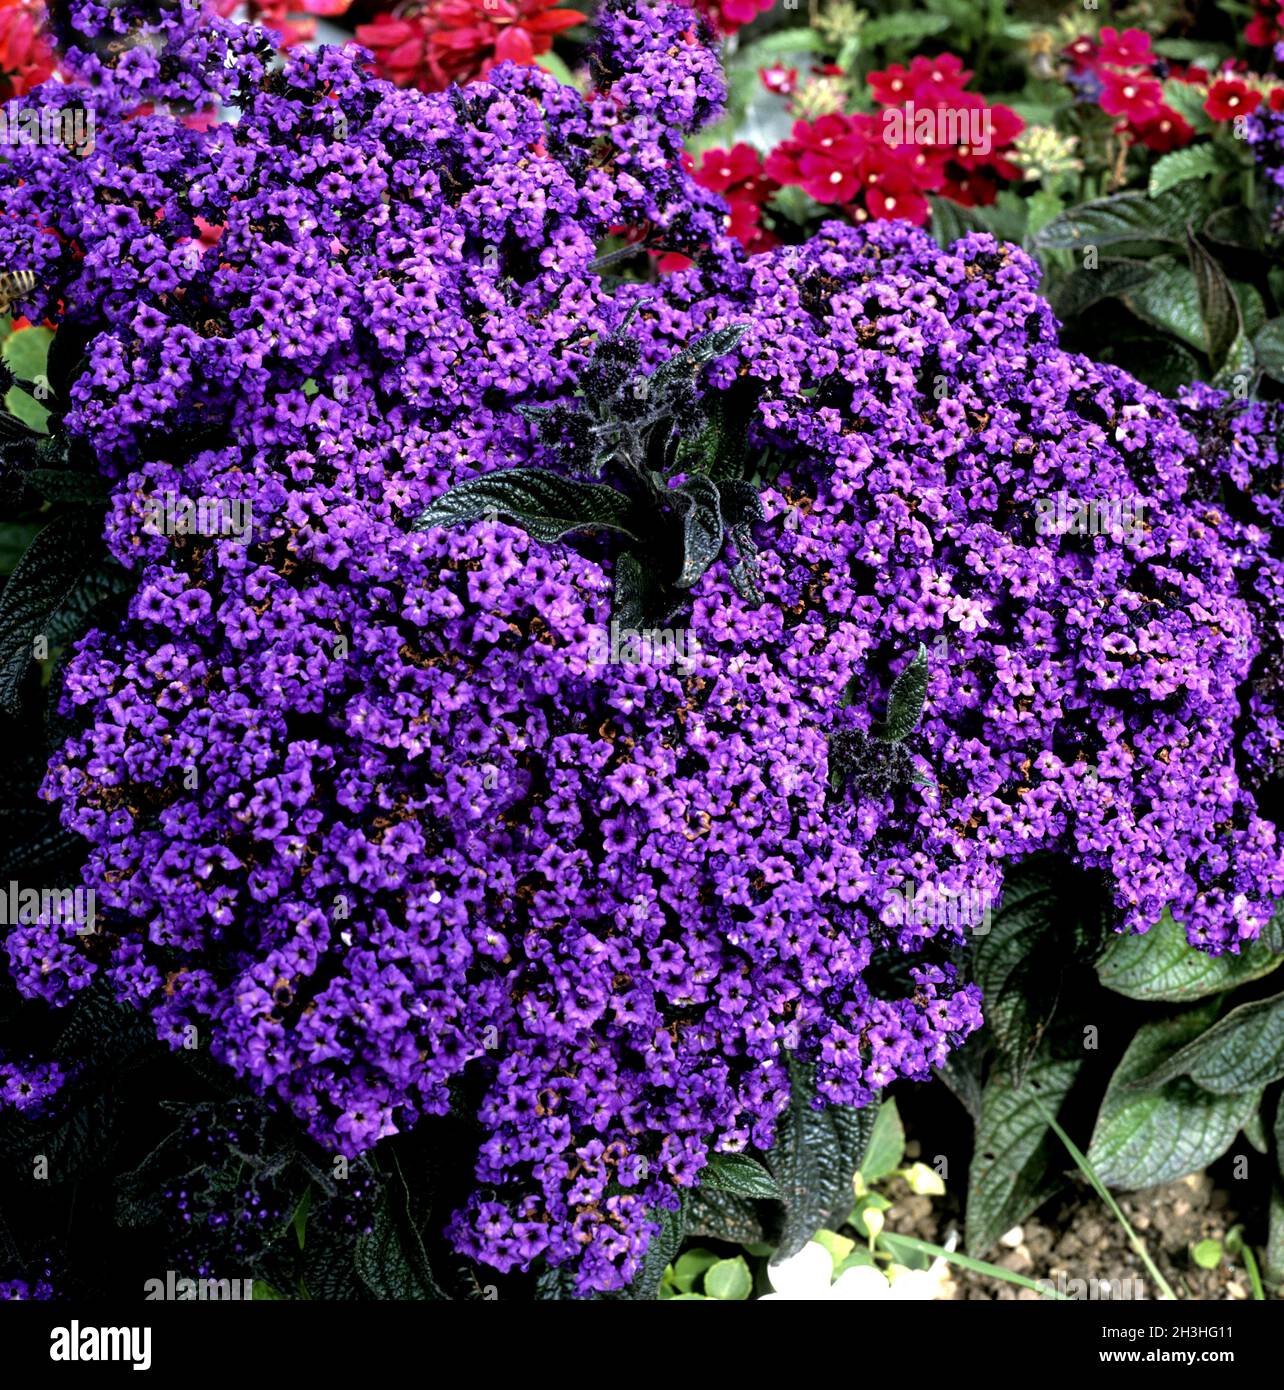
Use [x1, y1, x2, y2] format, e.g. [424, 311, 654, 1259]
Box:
[887, 1141, 1271, 1301]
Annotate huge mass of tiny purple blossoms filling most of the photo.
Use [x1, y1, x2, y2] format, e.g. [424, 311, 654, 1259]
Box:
[0, 4, 1284, 1290]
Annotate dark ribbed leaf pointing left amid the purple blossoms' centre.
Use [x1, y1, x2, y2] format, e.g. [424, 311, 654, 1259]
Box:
[411, 468, 636, 545]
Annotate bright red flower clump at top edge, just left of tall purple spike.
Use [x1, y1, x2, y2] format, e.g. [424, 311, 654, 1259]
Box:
[357, 0, 585, 92]
